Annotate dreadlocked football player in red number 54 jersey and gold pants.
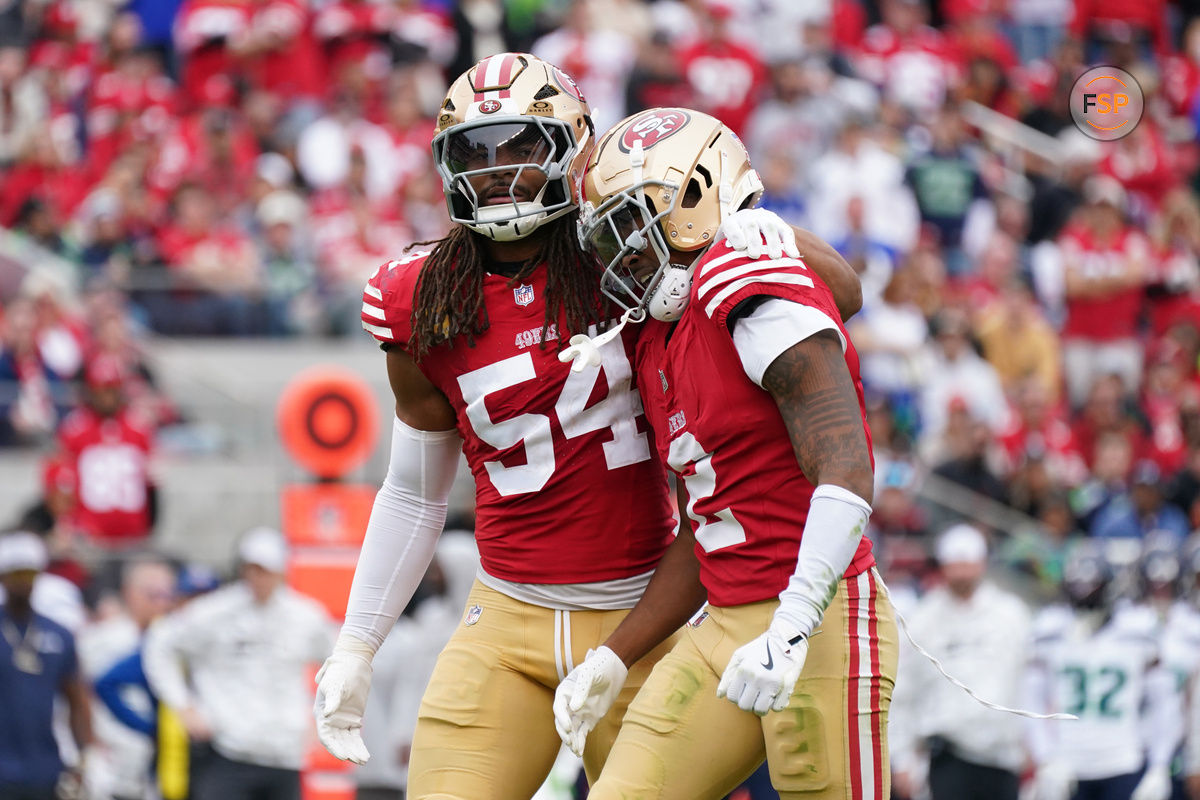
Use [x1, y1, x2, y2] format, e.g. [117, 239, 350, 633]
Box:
[316, 53, 858, 800]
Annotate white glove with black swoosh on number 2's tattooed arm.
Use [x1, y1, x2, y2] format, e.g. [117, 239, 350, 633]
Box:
[716, 619, 809, 716]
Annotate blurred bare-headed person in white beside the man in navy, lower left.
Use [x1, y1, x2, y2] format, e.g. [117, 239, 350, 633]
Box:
[77, 558, 175, 800]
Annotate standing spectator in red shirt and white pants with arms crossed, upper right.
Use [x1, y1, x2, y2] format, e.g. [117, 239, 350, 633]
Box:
[1058, 176, 1148, 407]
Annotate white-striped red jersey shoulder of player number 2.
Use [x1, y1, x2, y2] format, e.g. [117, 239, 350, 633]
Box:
[690, 240, 838, 324]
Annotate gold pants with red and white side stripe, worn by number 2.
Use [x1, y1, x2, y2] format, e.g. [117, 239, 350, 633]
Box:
[588, 570, 898, 800]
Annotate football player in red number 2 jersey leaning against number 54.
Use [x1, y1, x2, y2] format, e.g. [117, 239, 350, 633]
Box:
[556, 108, 898, 800]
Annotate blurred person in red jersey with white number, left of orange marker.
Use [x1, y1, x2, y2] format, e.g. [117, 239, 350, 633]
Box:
[59, 355, 154, 549]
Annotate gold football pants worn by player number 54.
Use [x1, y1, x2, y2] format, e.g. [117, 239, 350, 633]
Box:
[408, 581, 674, 800]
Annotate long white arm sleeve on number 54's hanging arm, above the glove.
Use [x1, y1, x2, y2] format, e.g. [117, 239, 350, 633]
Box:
[342, 419, 462, 654]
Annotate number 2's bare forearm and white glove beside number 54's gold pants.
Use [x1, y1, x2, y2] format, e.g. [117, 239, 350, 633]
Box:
[554, 485, 707, 757]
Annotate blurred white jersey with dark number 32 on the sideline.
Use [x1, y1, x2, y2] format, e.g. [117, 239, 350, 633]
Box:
[1031, 606, 1159, 780]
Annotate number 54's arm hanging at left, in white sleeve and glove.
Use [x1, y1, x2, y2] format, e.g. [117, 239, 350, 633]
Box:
[313, 349, 462, 764]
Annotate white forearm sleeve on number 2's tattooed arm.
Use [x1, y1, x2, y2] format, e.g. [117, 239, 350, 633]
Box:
[775, 483, 871, 636]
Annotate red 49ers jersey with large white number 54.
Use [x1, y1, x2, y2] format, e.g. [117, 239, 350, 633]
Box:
[362, 253, 673, 584]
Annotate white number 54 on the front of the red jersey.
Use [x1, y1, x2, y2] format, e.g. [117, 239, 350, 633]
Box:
[458, 338, 650, 497]
